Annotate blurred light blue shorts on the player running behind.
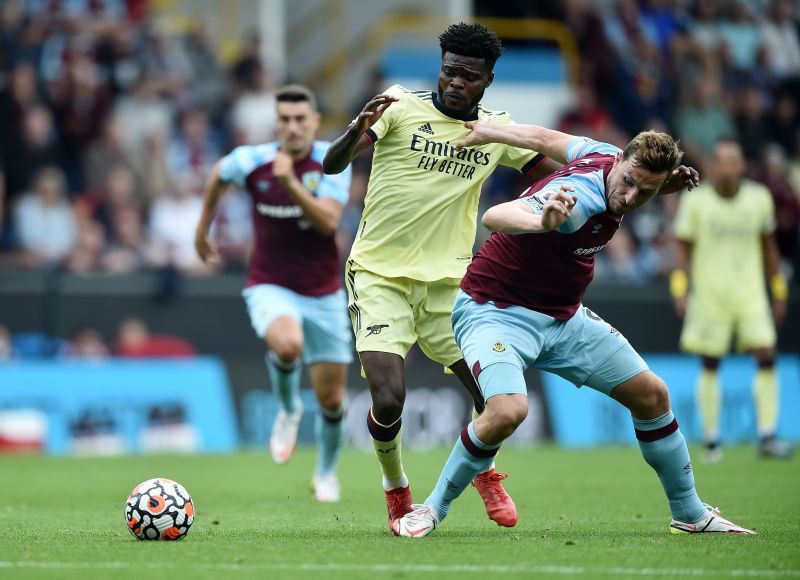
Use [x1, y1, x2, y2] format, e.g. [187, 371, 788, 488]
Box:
[242, 284, 353, 365]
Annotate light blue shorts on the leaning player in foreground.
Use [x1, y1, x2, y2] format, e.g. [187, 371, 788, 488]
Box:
[452, 290, 648, 399]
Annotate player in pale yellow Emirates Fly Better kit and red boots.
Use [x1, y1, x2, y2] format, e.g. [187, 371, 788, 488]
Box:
[324, 23, 556, 526]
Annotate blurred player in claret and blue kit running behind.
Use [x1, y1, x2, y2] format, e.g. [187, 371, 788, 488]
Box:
[195, 85, 352, 501]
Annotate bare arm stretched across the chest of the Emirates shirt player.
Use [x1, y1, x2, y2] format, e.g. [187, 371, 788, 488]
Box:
[456, 121, 575, 163]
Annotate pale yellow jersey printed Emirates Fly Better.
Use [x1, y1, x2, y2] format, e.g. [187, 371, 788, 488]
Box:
[350, 85, 544, 282]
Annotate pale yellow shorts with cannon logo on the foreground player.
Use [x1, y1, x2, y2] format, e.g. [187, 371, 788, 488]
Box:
[345, 260, 464, 367]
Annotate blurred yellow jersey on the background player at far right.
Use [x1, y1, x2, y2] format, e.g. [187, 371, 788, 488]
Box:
[675, 179, 775, 309]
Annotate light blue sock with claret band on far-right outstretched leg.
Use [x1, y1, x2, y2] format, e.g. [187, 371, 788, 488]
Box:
[633, 411, 707, 523]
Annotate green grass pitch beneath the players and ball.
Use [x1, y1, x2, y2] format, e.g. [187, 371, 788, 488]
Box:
[0, 447, 800, 580]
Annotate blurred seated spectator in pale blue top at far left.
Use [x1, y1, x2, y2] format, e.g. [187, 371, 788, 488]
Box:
[14, 167, 77, 266]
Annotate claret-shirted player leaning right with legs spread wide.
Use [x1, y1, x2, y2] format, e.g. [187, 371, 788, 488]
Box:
[392, 123, 752, 537]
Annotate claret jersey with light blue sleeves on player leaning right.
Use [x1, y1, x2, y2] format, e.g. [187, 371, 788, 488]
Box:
[461, 137, 622, 320]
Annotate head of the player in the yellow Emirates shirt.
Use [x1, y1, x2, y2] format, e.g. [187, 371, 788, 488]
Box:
[438, 22, 503, 116]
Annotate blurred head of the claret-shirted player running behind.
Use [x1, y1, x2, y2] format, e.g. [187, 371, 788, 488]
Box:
[275, 85, 320, 157]
